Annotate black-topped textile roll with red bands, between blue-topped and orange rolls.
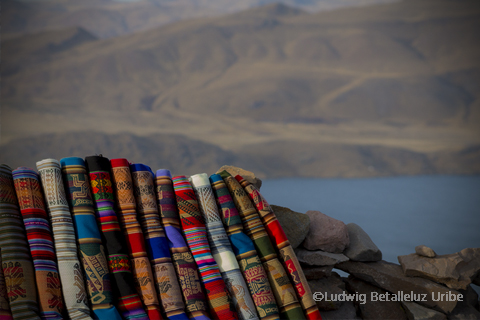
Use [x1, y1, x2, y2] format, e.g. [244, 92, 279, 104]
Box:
[85, 156, 148, 320]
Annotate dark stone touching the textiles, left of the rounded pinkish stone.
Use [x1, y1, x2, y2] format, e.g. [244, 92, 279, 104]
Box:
[271, 205, 310, 249]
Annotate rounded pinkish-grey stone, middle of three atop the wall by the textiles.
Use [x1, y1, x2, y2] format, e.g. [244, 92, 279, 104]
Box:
[303, 210, 350, 253]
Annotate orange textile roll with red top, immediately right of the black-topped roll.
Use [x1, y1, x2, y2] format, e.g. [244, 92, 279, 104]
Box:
[110, 159, 162, 319]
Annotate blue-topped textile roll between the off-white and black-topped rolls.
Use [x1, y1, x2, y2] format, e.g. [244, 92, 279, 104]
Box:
[60, 157, 122, 320]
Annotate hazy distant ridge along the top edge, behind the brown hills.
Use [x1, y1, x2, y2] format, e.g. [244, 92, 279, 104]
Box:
[1, 0, 396, 37]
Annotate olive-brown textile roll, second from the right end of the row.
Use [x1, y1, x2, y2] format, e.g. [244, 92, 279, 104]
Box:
[220, 171, 305, 320]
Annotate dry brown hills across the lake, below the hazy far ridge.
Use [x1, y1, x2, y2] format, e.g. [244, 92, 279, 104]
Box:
[0, 0, 480, 177]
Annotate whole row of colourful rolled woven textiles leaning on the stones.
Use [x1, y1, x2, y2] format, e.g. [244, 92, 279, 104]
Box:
[0, 156, 321, 320]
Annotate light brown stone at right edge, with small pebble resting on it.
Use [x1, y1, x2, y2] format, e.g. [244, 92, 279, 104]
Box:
[398, 248, 480, 290]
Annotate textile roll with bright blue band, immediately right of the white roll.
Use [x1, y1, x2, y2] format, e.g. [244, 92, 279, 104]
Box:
[210, 174, 279, 320]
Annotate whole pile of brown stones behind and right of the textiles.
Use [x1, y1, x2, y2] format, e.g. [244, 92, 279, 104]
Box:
[223, 166, 480, 320]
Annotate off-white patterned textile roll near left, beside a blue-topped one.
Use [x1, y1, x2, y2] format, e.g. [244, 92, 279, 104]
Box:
[37, 159, 91, 320]
